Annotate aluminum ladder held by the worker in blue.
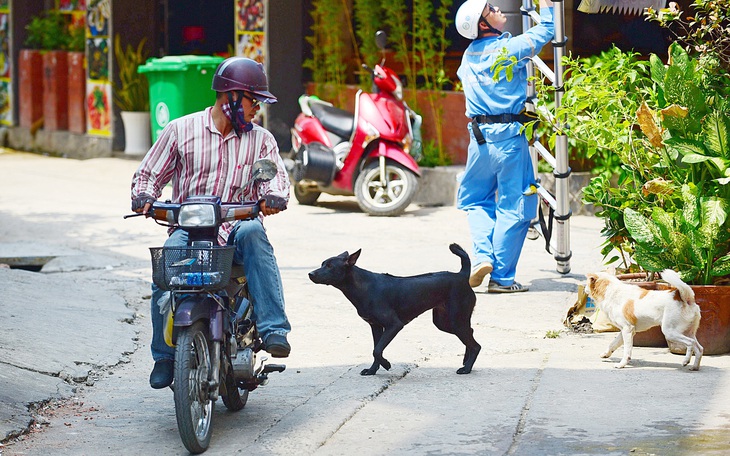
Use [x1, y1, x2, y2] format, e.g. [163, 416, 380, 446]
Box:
[520, 0, 572, 274]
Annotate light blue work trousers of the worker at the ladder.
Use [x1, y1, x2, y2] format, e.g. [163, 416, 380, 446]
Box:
[457, 127, 538, 285]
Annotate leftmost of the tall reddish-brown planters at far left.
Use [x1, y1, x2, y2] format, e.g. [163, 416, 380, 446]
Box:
[18, 49, 43, 128]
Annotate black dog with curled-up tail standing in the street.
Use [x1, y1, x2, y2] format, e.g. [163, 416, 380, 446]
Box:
[309, 244, 482, 375]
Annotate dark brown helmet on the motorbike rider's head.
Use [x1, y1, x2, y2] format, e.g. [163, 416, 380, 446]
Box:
[211, 57, 278, 103]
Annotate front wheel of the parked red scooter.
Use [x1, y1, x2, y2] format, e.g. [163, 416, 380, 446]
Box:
[355, 161, 418, 216]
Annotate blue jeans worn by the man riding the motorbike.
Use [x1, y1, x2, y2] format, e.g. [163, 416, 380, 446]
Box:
[150, 219, 291, 361]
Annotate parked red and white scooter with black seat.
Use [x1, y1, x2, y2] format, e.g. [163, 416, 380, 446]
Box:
[285, 31, 421, 216]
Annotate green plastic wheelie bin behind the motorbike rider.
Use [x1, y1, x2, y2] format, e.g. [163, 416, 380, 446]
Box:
[137, 55, 224, 142]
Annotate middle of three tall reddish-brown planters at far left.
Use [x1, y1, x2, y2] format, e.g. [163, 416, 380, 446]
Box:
[43, 51, 68, 131]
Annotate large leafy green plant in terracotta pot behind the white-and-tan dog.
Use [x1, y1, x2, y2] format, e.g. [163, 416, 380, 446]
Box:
[559, 0, 730, 354]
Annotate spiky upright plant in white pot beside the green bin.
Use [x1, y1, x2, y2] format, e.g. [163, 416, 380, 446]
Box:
[113, 35, 152, 155]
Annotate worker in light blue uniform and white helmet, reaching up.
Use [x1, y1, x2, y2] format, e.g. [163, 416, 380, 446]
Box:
[456, 0, 555, 293]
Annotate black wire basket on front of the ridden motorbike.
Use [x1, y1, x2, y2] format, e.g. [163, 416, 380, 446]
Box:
[150, 246, 236, 291]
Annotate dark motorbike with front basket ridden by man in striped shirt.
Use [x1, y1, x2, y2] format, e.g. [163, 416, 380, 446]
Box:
[124, 160, 286, 454]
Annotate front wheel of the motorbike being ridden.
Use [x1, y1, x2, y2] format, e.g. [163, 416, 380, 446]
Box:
[174, 321, 215, 454]
